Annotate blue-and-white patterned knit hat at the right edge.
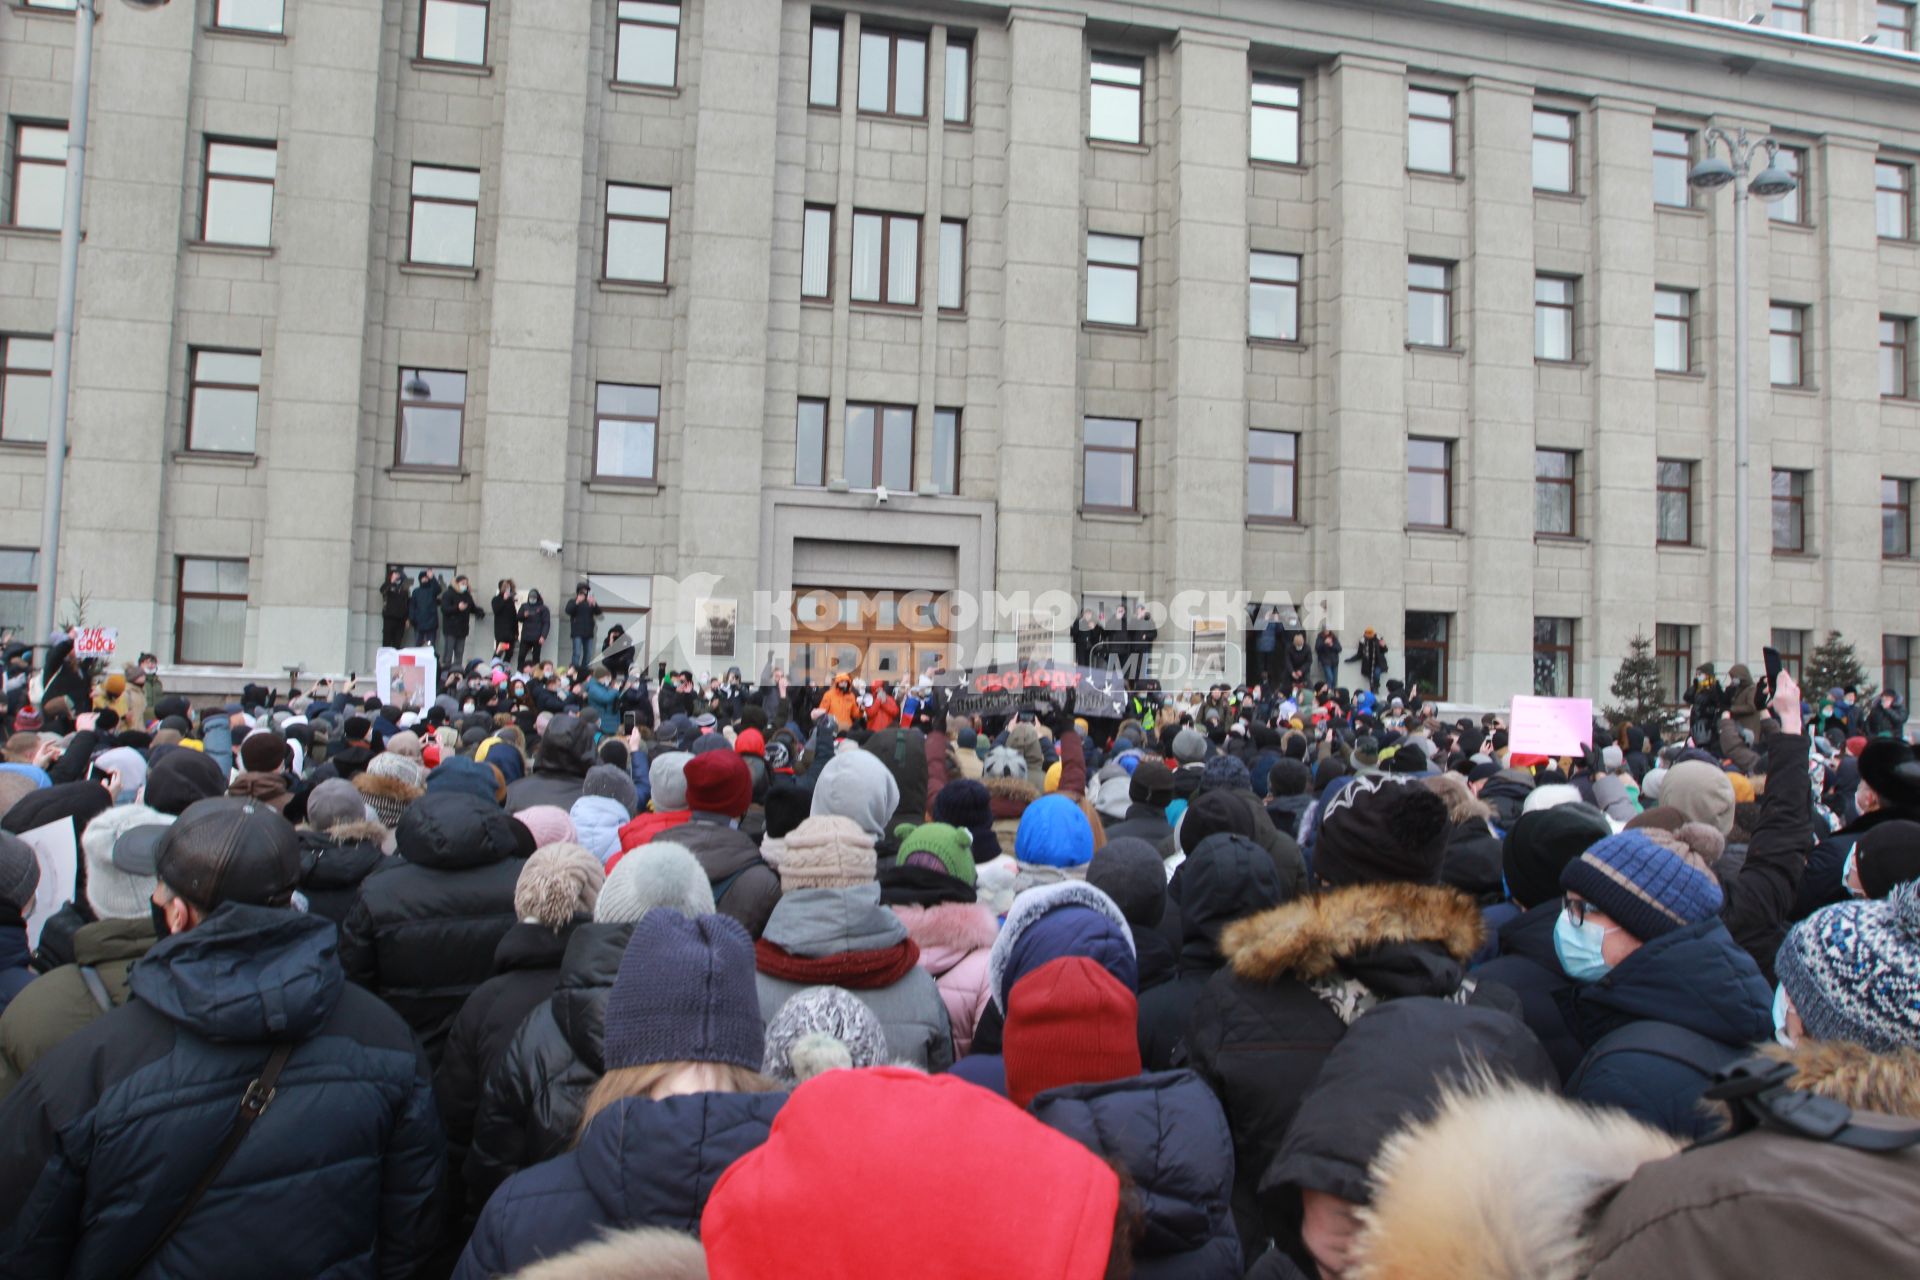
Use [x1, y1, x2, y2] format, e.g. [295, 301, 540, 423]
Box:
[1774, 881, 1920, 1054]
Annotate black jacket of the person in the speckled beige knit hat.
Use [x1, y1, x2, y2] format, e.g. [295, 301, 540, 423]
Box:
[434, 915, 586, 1171]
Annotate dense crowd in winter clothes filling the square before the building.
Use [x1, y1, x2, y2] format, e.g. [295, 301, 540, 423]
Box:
[0, 617, 1920, 1280]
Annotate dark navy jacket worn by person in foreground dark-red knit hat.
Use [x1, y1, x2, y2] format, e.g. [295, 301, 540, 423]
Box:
[1031, 1074, 1265, 1280]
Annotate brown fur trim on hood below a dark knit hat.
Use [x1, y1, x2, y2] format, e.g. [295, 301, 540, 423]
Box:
[1219, 883, 1486, 983]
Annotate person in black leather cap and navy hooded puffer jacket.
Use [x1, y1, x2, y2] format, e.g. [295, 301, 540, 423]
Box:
[0, 798, 445, 1276]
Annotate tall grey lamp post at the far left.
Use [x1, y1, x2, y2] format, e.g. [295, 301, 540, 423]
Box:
[29, 0, 167, 679]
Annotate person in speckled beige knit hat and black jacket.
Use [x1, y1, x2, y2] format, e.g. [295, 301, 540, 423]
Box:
[434, 844, 607, 1189]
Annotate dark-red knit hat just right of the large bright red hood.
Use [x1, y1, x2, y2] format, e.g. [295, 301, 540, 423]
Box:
[1000, 956, 1140, 1107]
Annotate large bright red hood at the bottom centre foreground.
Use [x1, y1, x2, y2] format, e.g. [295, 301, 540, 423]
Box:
[701, 1074, 1131, 1280]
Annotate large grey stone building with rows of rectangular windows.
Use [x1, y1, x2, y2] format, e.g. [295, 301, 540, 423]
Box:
[0, 0, 1920, 702]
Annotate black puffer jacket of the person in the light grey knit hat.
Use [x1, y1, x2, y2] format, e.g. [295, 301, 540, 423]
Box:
[465, 925, 634, 1209]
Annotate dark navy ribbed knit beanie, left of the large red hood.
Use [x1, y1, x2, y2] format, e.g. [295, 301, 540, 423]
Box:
[605, 912, 766, 1071]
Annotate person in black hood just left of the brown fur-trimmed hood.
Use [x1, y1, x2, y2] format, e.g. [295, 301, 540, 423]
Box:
[1136, 833, 1288, 1071]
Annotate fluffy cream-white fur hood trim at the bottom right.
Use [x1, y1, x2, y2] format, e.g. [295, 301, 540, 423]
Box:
[1346, 1084, 1682, 1280]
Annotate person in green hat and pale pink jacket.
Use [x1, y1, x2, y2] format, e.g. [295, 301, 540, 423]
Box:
[879, 821, 1000, 1057]
